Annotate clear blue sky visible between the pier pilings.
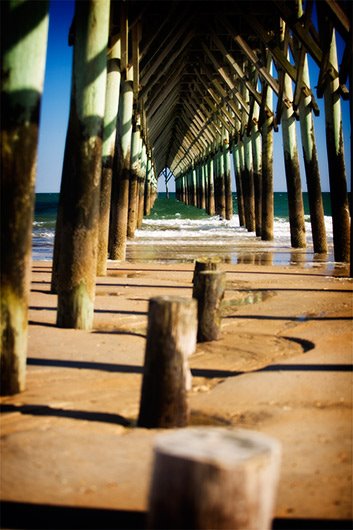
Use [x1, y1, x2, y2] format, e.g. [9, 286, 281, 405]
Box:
[36, 0, 351, 193]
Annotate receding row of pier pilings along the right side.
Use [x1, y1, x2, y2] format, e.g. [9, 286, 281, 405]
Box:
[176, 35, 351, 262]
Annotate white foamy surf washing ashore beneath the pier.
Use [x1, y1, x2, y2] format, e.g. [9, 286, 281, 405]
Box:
[32, 207, 333, 261]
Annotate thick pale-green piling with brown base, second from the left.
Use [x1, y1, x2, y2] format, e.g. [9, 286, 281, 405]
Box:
[57, 0, 110, 329]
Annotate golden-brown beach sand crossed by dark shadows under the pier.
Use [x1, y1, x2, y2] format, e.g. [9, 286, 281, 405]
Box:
[1, 262, 352, 520]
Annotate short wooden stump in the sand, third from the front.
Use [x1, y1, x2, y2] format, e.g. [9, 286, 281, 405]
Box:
[193, 270, 226, 342]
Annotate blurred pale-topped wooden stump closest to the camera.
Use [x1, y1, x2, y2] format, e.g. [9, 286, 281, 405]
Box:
[147, 427, 281, 530]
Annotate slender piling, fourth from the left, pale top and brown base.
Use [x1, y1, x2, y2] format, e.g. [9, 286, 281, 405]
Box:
[110, 76, 133, 260]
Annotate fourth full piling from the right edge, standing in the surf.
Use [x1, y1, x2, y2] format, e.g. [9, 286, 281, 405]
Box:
[261, 58, 274, 241]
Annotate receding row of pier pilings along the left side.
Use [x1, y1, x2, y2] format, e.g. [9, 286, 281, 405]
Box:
[1, 0, 157, 395]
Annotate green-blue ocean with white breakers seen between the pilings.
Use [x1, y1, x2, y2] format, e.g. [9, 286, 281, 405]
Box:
[32, 192, 334, 267]
